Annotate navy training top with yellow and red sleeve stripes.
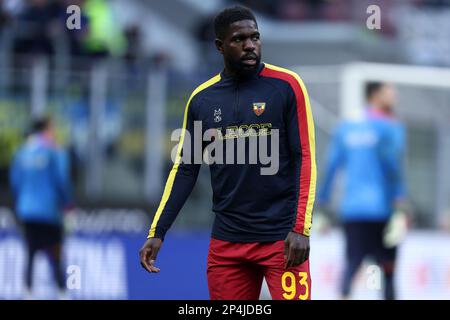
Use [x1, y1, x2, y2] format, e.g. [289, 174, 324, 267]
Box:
[148, 63, 316, 242]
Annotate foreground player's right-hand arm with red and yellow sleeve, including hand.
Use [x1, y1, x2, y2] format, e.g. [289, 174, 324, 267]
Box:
[285, 75, 316, 268]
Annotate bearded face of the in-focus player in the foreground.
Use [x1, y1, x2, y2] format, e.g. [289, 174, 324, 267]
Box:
[216, 20, 261, 75]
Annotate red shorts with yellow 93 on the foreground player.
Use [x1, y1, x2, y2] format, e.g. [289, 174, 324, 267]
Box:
[207, 239, 311, 300]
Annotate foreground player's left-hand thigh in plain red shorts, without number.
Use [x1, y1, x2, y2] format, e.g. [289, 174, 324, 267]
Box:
[207, 264, 264, 300]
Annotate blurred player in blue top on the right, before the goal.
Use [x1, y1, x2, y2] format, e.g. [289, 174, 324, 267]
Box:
[317, 82, 407, 300]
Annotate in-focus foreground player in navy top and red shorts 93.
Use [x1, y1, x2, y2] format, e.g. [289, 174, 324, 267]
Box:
[140, 6, 316, 300]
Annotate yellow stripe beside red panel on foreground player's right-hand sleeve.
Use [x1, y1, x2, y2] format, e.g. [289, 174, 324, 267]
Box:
[265, 63, 317, 236]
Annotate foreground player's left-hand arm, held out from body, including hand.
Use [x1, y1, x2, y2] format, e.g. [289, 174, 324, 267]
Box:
[139, 94, 201, 272]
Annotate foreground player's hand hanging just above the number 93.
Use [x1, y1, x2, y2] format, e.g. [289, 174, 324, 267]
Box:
[284, 231, 309, 269]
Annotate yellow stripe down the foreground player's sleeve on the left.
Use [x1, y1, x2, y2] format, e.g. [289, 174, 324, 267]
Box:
[147, 74, 220, 238]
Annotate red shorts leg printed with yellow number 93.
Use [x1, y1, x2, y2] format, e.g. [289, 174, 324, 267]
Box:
[265, 260, 311, 300]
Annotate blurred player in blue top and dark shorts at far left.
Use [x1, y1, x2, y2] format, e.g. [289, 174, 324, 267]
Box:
[11, 117, 71, 299]
